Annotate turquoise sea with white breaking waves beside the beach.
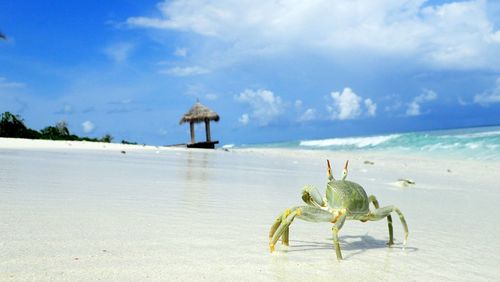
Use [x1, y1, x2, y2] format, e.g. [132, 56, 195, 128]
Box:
[235, 126, 500, 160]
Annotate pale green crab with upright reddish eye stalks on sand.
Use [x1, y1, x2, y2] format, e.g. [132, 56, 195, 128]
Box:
[269, 160, 408, 260]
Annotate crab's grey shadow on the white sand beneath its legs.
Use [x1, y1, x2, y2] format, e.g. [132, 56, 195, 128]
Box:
[283, 235, 418, 257]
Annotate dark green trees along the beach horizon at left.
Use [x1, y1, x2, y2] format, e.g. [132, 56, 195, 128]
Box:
[0, 112, 117, 143]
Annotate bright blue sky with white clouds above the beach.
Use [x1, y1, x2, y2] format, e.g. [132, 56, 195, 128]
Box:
[0, 0, 500, 145]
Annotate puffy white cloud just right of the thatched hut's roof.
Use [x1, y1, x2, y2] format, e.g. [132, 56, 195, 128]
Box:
[235, 89, 285, 126]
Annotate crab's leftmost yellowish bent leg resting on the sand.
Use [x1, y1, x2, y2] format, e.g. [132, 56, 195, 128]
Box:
[269, 206, 334, 252]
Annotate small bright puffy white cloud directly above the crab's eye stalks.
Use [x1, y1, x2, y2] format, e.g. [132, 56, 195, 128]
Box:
[327, 87, 377, 120]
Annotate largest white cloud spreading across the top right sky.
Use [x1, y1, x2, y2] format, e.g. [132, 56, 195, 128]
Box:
[127, 0, 500, 69]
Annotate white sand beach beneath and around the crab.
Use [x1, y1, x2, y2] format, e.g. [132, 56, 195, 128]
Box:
[0, 138, 500, 281]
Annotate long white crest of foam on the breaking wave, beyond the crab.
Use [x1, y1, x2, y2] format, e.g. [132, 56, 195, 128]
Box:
[299, 134, 400, 148]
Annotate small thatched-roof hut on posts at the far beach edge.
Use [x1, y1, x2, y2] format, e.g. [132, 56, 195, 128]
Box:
[179, 102, 220, 149]
